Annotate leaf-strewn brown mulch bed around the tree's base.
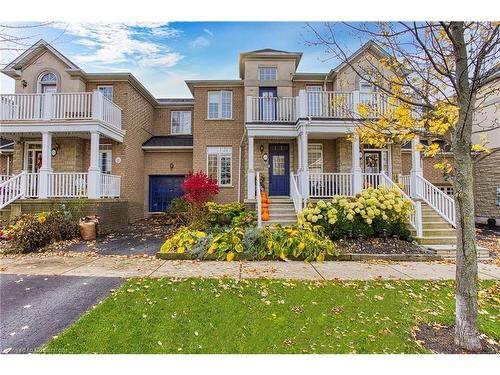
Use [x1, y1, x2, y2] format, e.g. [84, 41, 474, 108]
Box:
[413, 323, 500, 354]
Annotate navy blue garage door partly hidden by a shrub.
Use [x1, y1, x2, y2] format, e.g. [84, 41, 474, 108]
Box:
[149, 176, 184, 212]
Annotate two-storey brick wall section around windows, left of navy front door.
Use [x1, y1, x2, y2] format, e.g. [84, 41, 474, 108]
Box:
[193, 86, 244, 202]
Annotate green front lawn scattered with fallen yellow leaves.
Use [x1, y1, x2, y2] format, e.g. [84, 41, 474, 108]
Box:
[41, 279, 500, 353]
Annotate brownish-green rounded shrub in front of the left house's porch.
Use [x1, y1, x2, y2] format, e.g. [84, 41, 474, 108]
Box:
[6, 211, 78, 253]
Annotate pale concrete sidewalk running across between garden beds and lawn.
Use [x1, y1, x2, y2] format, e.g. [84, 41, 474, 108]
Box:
[0, 255, 500, 280]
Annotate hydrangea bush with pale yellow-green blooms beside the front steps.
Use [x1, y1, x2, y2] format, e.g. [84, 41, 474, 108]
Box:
[299, 187, 411, 239]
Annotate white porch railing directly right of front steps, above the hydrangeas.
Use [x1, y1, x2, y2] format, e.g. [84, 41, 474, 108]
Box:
[309, 173, 353, 198]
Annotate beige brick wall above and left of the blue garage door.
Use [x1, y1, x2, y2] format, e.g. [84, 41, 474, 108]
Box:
[144, 152, 193, 215]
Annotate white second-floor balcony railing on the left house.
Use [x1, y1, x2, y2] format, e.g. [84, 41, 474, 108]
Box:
[0, 91, 121, 129]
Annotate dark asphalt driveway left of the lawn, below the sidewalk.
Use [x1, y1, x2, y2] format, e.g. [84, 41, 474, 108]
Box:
[0, 275, 124, 353]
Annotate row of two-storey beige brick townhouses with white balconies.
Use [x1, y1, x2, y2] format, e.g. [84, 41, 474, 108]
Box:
[0, 40, 500, 236]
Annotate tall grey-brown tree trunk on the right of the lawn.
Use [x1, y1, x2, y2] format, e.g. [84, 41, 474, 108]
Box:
[451, 22, 481, 351]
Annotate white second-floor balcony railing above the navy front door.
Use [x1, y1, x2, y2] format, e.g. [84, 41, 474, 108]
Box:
[246, 90, 389, 123]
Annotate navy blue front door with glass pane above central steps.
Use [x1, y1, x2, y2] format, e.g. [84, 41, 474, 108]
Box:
[269, 144, 290, 196]
